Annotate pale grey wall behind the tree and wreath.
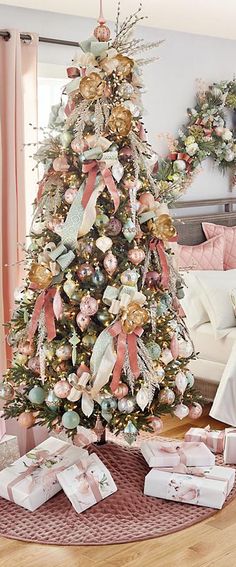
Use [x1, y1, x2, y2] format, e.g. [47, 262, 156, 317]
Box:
[0, 0, 236, 204]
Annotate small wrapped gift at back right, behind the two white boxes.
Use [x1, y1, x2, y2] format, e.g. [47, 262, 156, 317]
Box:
[184, 425, 225, 453]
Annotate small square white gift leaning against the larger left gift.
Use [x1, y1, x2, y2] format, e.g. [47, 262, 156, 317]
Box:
[57, 453, 117, 514]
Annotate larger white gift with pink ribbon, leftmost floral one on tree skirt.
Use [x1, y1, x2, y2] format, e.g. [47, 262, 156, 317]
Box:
[0, 437, 88, 512]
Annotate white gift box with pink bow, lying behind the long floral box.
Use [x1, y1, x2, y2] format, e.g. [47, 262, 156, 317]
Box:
[140, 439, 215, 467]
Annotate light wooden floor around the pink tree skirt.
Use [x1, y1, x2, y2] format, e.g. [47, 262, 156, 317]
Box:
[0, 415, 236, 567]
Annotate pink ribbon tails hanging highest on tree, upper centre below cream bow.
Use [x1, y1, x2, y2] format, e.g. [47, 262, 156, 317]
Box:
[81, 160, 120, 212]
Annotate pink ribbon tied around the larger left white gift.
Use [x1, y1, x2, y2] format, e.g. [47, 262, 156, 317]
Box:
[7, 445, 68, 502]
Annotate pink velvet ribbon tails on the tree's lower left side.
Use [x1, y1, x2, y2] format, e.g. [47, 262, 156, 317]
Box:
[28, 288, 56, 342]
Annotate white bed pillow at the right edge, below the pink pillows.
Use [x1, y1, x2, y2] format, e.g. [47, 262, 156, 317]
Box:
[195, 270, 236, 338]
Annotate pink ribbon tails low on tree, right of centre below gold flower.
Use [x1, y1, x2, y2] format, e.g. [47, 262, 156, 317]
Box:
[108, 321, 143, 392]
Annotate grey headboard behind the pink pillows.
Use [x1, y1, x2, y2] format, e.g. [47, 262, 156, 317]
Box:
[172, 197, 236, 245]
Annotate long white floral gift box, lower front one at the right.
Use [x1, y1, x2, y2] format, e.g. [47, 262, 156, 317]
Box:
[144, 466, 235, 509]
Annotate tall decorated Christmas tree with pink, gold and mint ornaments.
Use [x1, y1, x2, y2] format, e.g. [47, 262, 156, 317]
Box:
[1, 2, 202, 442]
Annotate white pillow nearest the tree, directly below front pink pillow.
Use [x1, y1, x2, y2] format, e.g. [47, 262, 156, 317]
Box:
[180, 270, 210, 329]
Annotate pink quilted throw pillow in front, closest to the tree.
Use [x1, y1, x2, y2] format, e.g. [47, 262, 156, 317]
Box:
[177, 236, 224, 270]
